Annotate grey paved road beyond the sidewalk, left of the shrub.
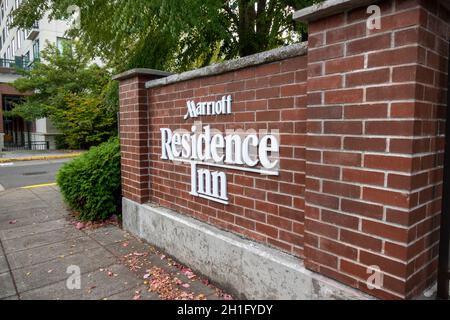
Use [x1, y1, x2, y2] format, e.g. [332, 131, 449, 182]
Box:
[0, 159, 72, 191]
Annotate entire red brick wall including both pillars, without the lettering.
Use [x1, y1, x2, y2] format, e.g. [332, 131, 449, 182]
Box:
[120, 0, 450, 298]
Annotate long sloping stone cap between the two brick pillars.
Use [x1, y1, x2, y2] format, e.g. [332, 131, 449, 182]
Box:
[145, 42, 308, 88]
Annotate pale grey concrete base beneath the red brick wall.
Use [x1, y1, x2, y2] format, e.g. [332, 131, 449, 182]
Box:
[122, 198, 371, 299]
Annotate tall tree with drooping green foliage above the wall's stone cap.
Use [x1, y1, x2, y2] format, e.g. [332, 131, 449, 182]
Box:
[14, 0, 319, 71]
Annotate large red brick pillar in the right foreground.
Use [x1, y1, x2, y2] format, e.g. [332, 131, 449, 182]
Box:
[298, 0, 450, 298]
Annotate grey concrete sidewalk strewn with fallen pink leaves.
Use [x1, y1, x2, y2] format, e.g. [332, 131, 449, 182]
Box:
[0, 186, 229, 300]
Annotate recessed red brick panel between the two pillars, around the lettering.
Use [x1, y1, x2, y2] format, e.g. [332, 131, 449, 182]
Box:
[148, 56, 307, 257]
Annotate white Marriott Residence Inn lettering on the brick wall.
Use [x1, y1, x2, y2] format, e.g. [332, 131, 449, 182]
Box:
[160, 96, 280, 204]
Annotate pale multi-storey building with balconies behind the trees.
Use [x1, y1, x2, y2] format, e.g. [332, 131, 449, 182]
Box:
[0, 0, 69, 150]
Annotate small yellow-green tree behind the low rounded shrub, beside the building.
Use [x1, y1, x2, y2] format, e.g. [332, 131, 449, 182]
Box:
[9, 43, 118, 149]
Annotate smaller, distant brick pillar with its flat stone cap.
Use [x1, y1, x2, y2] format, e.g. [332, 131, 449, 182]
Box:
[113, 69, 169, 203]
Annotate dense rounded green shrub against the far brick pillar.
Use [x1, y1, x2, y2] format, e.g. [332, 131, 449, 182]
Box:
[56, 138, 121, 220]
